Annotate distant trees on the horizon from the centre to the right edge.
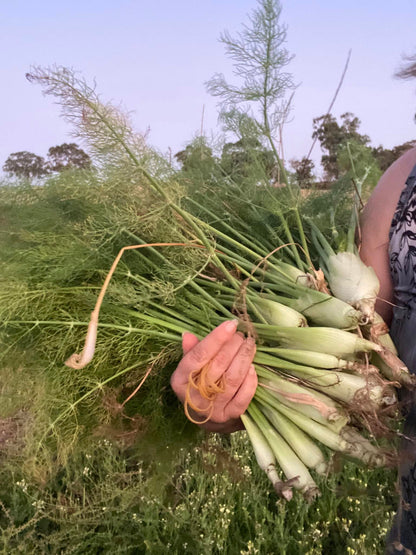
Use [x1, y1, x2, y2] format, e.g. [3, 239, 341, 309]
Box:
[175, 112, 416, 188]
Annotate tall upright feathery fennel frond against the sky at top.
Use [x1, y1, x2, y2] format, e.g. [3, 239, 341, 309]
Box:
[207, 0, 294, 187]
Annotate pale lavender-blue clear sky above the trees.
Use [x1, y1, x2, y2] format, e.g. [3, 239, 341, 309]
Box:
[0, 0, 416, 176]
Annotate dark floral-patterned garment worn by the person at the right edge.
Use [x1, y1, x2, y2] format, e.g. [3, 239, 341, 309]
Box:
[387, 166, 416, 555]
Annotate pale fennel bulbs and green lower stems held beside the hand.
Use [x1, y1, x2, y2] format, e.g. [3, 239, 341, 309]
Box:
[61, 216, 404, 499]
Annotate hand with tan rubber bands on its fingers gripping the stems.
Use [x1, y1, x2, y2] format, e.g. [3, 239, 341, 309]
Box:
[171, 321, 257, 433]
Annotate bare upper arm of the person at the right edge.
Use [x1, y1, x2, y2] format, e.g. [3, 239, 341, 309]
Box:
[360, 148, 416, 324]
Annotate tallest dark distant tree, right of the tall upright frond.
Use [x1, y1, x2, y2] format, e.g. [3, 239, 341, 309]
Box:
[312, 112, 370, 181]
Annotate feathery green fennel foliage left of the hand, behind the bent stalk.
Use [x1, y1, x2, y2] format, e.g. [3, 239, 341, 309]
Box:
[0, 161, 211, 478]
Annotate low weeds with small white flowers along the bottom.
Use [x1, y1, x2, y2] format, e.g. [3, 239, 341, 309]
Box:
[0, 433, 395, 555]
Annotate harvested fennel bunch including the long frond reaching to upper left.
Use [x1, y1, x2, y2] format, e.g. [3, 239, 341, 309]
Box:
[6, 70, 409, 498]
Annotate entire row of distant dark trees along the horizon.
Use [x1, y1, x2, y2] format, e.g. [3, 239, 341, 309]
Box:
[3, 112, 416, 188]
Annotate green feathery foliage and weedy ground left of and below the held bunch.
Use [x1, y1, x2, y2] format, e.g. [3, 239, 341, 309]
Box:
[0, 173, 397, 555]
